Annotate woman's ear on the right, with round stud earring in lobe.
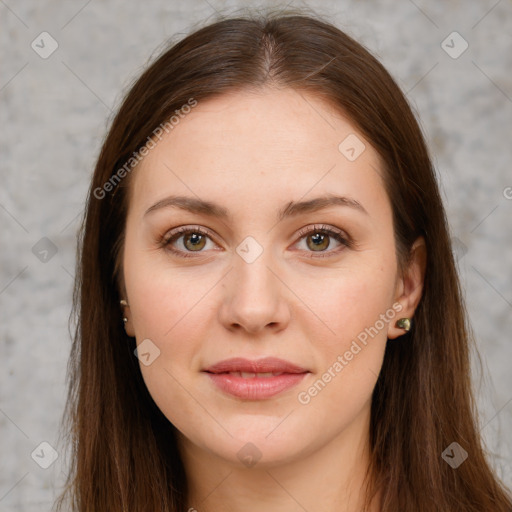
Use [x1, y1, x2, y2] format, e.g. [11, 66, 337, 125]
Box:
[388, 236, 427, 339]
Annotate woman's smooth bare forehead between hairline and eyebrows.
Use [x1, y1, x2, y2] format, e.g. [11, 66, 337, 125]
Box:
[131, 89, 385, 222]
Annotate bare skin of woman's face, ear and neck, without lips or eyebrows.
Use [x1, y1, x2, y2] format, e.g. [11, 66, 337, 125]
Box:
[121, 89, 426, 512]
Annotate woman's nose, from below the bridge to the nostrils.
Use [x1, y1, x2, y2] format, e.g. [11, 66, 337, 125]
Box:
[219, 251, 291, 334]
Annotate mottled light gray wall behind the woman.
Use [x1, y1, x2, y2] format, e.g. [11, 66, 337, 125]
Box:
[0, 0, 512, 512]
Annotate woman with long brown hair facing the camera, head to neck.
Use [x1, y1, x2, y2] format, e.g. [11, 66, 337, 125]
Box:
[53, 8, 512, 512]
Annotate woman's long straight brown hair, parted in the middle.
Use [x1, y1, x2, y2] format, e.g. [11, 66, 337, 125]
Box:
[56, 11, 512, 512]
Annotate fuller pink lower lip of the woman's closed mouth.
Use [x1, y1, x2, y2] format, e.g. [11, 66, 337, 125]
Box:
[206, 372, 308, 400]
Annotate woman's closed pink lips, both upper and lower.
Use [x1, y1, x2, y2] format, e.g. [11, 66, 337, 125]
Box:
[203, 358, 311, 400]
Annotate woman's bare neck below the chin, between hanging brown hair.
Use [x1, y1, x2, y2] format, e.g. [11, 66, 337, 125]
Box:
[178, 408, 379, 512]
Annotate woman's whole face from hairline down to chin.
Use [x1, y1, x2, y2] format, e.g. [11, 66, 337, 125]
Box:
[123, 89, 411, 466]
